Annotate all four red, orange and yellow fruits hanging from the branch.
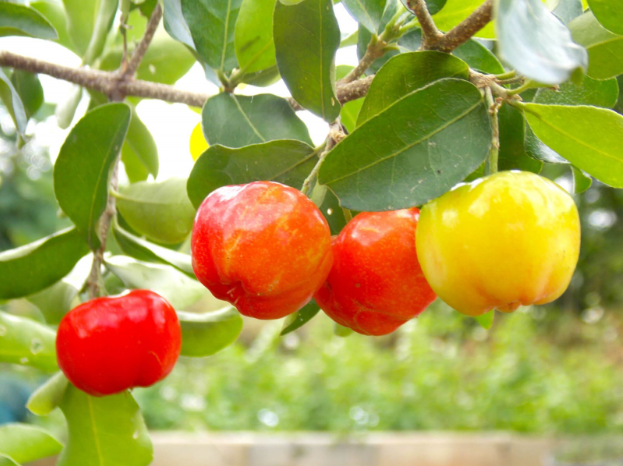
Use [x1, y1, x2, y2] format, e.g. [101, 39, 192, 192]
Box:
[57, 171, 580, 395]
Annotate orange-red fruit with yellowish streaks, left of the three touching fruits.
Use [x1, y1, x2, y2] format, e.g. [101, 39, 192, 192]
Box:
[191, 181, 333, 319]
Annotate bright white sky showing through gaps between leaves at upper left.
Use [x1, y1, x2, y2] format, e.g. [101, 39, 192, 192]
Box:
[0, 3, 357, 183]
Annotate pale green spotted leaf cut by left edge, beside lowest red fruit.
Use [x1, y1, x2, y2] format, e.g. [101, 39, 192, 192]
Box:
[0, 312, 58, 372]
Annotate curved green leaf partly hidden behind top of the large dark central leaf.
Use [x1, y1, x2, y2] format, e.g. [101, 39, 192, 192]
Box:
[357, 51, 469, 126]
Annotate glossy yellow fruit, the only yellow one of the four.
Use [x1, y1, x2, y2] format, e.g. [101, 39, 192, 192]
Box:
[417, 171, 580, 316]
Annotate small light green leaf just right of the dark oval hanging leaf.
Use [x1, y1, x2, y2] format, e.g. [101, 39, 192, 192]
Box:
[121, 107, 159, 183]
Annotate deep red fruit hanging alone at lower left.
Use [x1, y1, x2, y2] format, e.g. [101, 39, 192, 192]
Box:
[56, 290, 182, 396]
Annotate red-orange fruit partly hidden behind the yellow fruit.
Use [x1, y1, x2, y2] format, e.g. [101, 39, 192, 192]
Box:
[314, 208, 436, 335]
